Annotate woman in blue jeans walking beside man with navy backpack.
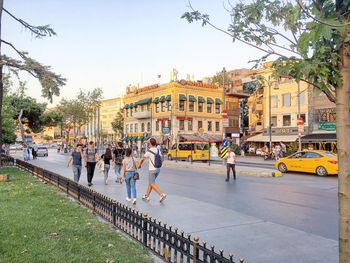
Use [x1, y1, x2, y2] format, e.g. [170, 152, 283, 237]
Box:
[121, 148, 137, 205]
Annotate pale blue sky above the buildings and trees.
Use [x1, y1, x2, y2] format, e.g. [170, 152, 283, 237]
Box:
[2, 0, 262, 104]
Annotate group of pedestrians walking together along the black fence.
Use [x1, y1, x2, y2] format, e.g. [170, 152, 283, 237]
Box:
[67, 138, 166, 204]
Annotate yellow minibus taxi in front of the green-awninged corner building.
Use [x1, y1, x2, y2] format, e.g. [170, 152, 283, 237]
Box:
[168, 142, 209, 161]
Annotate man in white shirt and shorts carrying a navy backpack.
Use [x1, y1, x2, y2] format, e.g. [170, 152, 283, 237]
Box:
[139, 138, 166, 202]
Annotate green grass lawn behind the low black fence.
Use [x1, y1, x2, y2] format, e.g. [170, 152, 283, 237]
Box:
[0, 168, 153, 263]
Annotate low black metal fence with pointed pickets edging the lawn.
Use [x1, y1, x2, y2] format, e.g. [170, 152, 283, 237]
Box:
[1, 155, 244, 263]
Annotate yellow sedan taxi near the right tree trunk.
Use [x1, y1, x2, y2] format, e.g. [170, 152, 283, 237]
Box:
[275, 150, 338, 176]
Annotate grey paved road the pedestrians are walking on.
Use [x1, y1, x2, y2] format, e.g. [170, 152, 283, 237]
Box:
[12, 152, 338, 263]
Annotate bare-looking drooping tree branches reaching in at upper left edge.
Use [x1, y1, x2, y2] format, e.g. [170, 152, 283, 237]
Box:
[0, 0, 66, 152]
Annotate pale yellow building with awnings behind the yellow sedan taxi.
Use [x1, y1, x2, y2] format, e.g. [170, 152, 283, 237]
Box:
[247, 63, 309, 147]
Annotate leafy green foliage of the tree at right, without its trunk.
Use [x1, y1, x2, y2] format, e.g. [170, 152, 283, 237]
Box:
[182, 0, 350, 102]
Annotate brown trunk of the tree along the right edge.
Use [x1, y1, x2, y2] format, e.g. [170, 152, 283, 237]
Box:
[336, 46, 350, 263]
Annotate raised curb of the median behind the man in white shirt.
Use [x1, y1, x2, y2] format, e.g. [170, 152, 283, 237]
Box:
[163, 162, 283, 177]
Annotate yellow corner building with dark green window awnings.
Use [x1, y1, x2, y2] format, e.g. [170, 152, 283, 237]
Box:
[124, 80, 230, 146]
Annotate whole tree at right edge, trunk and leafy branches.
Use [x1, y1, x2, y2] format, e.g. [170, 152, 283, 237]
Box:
[182, 0, 350, 263]
